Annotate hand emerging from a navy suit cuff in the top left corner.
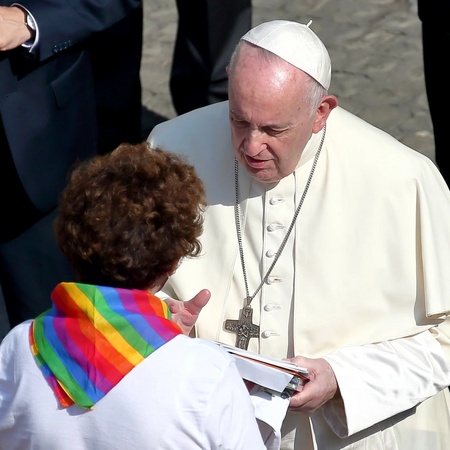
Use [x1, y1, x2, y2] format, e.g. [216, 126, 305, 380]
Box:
[0, 6, 31, 52]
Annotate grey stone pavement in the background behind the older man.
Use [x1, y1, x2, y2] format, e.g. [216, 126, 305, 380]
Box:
[0, 0, 434, 340]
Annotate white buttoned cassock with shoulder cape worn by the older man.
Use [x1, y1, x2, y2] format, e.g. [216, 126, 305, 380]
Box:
[149, 102, 450, 450]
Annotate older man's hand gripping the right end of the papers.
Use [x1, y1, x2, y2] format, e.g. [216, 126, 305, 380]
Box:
[289, 356, 338, 414]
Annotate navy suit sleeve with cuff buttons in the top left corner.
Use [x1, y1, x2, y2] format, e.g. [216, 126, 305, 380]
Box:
[14, 0, 142, 61]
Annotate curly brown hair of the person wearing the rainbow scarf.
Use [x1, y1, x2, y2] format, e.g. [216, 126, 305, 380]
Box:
[54, 143, 206, 289]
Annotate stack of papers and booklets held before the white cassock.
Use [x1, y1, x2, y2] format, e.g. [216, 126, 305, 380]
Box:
[215, 341, 309, 394]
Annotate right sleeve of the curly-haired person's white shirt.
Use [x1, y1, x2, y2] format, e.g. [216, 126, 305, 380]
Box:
[205, 362, 265, 450]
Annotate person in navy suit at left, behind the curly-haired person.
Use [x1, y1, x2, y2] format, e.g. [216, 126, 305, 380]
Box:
[0, 0, 142, 326]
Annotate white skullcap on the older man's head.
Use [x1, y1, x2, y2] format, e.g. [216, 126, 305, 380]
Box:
[241, 20, 331, 90]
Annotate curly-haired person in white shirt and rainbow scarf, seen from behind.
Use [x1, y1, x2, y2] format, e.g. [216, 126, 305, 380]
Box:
[0, 144, 265, 450]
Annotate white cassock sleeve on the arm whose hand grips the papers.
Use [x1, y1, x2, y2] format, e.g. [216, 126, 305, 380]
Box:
[322, 331, 450, 437]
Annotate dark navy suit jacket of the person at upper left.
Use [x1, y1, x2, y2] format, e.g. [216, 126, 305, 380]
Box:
[0, 0, 142, 211]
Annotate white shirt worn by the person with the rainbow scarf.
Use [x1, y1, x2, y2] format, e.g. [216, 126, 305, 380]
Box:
[0, 321, 265, 450]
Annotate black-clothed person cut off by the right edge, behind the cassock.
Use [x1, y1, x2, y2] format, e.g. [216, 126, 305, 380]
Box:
[418, 0, 450, 186]
